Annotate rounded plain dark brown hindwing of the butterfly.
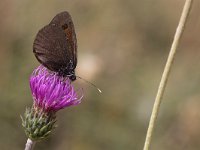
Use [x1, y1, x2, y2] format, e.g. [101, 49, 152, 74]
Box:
[33, 24, 72, 72]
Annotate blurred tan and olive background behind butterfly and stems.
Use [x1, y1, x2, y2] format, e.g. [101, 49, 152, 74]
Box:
[0, 0, 200, 150]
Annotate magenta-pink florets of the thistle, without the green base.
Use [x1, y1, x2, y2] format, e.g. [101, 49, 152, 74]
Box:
[30, 65, 83, 112]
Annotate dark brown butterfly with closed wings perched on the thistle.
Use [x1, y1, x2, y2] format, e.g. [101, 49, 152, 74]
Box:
[33, 11, 77, 81]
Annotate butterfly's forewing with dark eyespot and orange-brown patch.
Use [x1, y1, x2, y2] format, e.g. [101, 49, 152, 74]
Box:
[50, 11, 77, 69]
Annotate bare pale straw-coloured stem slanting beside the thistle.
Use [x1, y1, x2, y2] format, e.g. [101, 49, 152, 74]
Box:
[143, 0, 193, 150]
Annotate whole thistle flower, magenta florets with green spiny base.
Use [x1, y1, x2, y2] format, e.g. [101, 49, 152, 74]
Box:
[22, 66, 83, 141]
